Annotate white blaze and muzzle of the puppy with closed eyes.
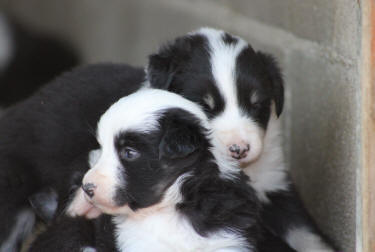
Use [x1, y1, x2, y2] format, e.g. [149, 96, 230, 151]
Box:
[192, 28, 264, 165]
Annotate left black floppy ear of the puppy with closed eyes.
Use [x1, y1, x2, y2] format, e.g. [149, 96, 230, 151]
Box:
[146, 37, 191, 90]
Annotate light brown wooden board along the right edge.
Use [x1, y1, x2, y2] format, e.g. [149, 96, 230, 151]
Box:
[360, 0, 375, 252]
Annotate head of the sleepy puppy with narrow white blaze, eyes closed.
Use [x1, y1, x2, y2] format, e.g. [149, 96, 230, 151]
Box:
[147, 28, 284, 164]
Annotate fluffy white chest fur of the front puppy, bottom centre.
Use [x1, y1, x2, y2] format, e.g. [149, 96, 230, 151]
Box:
[114, 209, 252, 252]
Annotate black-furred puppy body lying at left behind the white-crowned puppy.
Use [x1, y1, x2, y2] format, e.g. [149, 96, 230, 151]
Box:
[0, 64, 144, 252]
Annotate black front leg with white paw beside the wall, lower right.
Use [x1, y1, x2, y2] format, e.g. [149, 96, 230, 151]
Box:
[262, 186, 335, 252]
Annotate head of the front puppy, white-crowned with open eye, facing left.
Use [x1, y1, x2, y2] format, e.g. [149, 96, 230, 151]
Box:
[77, 90, 209, 214]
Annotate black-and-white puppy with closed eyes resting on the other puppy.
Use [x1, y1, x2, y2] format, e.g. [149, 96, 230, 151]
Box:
[147, 28, 333, 251]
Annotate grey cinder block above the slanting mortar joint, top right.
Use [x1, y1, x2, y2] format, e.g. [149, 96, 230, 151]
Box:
[214, 0, 339, 44]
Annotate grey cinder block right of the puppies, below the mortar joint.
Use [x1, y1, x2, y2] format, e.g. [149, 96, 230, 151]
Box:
[287, 51, 360, 252]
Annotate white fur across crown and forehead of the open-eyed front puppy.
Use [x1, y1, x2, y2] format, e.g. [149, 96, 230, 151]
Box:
[98, 88, 207, 147]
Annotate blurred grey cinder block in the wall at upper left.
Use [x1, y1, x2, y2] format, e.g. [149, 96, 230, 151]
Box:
[2, 0, 214, 65]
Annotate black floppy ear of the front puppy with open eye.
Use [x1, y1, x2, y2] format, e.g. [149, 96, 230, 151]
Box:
[159, 118, 204, 168]
